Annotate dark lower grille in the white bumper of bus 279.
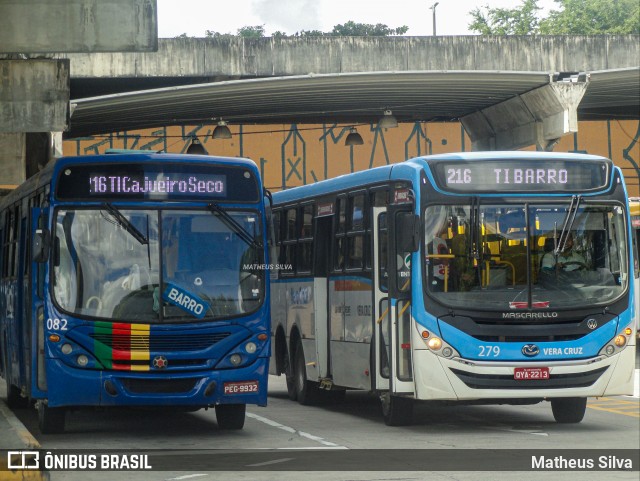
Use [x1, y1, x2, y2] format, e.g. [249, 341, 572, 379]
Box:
[451, 367, 608, 389]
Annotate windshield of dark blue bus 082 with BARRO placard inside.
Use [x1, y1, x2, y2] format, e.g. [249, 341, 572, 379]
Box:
[52, 204, 265, 323]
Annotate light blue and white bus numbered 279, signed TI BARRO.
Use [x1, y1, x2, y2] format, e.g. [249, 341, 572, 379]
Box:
[270, 152, 636, 425]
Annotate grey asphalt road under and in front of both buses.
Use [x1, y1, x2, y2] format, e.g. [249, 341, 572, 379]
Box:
[2, 360, 640, 481]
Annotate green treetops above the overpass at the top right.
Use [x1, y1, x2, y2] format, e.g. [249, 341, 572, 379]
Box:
[469, 0, 640, 35]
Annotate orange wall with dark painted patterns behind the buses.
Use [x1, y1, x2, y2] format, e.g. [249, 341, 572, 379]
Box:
[63, 120, 640, 196]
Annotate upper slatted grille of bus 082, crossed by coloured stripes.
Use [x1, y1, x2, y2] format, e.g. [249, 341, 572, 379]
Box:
[91, 332, 231, 352]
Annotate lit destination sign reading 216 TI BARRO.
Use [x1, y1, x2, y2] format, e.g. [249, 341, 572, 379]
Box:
[434, 160, 608, 192]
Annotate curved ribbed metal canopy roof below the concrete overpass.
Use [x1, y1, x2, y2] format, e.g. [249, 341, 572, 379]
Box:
[65, 68, 640, 138]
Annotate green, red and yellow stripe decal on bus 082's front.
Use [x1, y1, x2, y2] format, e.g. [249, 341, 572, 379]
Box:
[94, 322, 150, 371]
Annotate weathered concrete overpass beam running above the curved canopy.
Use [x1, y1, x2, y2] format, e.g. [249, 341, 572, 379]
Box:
[62, 35, 640, 99]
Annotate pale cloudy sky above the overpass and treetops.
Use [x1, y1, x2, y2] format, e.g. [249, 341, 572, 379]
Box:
[157, 0, 559, 38]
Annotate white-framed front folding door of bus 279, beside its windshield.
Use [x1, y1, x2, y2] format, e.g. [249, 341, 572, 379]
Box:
[372, 203, 417, 394]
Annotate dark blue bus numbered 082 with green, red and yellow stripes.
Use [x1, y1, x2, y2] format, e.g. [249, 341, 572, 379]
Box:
[0, 153, 270, 433]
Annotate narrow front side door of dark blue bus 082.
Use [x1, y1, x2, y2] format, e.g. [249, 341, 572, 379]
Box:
[30, 208, 51, 398]
